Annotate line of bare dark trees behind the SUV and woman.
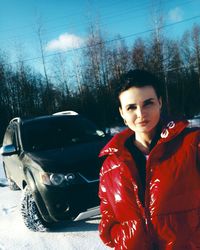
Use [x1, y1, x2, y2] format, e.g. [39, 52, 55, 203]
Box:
[0, 24, 200, 141]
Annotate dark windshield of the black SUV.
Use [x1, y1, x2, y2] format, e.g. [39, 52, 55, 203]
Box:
[21, 116, 105, 151]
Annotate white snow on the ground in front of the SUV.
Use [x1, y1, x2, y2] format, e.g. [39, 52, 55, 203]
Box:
[0, 157, 110, 250]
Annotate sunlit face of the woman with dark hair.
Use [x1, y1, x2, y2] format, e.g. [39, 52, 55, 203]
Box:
[119, 86, 162, 134]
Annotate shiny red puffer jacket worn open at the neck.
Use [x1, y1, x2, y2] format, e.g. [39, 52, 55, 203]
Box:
[99, 122, 200, 250]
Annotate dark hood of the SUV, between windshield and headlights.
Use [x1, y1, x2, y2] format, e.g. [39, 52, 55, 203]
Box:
[26, 139, 108, 173]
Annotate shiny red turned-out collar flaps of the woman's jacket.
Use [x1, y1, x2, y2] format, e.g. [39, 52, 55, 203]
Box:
[99, 120, 188, 157]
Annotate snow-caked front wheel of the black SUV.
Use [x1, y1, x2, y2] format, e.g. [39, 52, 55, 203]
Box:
[21, 186, 49, 232]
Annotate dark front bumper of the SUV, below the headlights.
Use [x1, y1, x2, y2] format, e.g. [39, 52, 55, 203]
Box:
[35, 181, 100, 222]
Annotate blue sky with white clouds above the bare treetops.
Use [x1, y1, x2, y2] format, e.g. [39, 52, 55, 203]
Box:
[0, 0, 200, 73]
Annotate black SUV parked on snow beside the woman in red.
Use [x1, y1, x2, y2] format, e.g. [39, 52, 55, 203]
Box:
[1, 111, 109, 231]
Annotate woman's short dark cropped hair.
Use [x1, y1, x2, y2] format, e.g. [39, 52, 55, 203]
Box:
[117, 69, 161, 105]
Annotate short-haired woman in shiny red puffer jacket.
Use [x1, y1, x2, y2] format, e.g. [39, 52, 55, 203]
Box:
[99, 70, 200, 250]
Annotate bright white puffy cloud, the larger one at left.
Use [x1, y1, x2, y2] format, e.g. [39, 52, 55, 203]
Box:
[46, 33, 83, 51]
